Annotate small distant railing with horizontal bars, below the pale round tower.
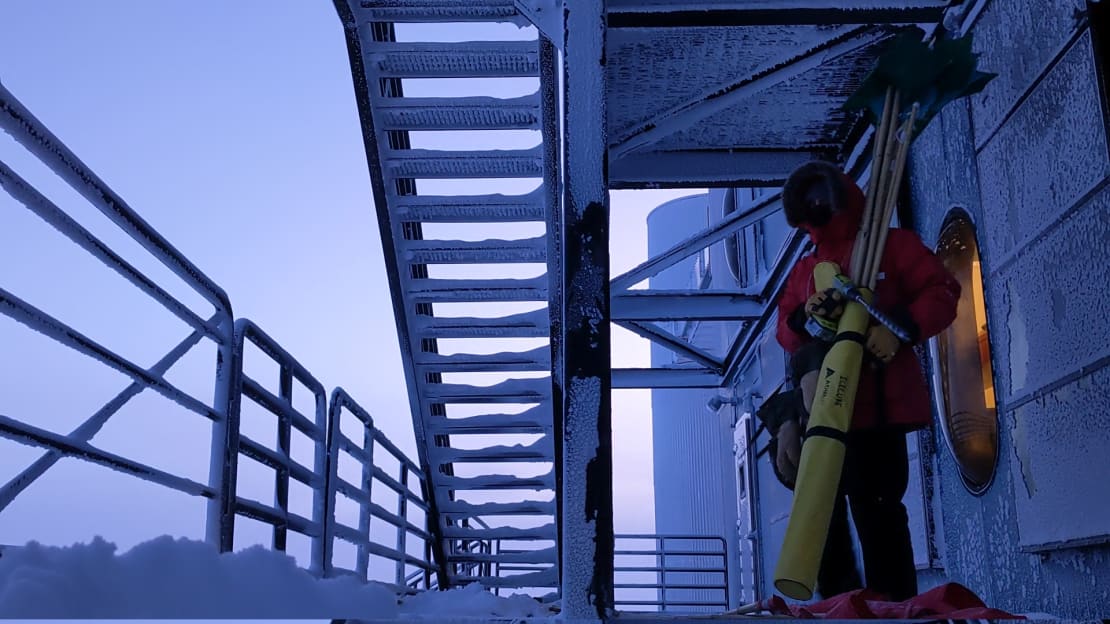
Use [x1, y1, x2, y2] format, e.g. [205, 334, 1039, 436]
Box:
[613, 534, 729, 612]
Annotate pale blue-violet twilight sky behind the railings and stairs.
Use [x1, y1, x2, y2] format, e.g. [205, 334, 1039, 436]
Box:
[0, 0, 705, 558]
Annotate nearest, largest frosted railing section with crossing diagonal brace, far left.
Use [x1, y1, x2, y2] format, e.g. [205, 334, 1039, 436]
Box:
[0, 78, 234, 550]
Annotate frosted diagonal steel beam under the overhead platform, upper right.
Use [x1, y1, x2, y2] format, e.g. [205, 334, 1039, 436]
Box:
[609, 27, 888, 157]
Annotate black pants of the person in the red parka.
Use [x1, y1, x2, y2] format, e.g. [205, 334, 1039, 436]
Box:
[817, 430, 917, 601]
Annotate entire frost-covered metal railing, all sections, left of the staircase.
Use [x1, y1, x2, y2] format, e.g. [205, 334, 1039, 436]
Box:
[0, 84, 437, 588]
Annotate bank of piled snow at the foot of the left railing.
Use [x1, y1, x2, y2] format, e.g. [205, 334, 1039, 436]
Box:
[0, 536, 553, 622]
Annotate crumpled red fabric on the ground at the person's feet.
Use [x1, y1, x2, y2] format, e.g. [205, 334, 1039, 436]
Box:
[761, 583, 1025, 620]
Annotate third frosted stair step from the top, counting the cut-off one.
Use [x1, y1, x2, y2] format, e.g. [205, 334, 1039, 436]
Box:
[374, 93, 542, 130]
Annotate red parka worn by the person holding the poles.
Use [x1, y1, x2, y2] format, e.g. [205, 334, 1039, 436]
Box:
[777, 177, 960, 430]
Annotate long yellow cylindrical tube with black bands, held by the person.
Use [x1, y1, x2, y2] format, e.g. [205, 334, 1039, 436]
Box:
[775, 270, 870, 600]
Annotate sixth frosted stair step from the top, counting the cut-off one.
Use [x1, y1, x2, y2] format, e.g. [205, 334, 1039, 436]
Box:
[397, 236, 547, 264]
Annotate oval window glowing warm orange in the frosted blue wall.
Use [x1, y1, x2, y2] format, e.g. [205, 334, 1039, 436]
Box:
[932, 213, 998, 494]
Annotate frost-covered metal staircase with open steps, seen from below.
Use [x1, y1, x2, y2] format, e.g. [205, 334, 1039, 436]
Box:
[335, 0, 558, 590]
